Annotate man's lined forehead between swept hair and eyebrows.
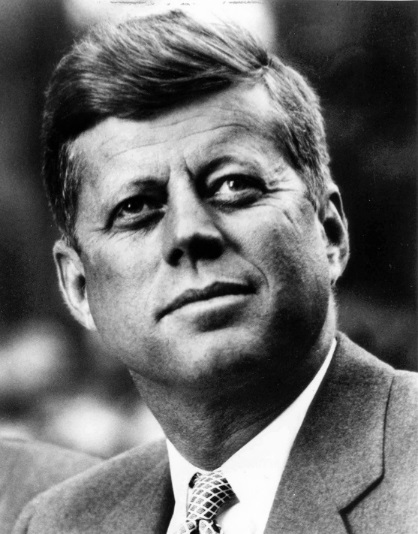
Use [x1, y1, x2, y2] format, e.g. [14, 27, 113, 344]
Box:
[73, 85, 277, 175]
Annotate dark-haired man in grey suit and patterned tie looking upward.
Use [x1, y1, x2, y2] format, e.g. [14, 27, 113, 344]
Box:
[11, 11, 418, 534]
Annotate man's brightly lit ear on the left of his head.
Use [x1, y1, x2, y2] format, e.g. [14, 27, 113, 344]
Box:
[53, 239, 96, 330]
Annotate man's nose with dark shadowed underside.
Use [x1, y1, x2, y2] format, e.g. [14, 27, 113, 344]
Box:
[162, 178, 224, 267]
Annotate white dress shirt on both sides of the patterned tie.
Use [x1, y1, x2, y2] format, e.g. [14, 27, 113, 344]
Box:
[167, 340, 336, 534]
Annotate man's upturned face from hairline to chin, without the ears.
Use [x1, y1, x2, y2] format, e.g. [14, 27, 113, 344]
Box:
[64, 86, 342, 390]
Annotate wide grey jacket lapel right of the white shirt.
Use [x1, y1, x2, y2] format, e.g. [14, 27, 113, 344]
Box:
[265, 335, 392, 534]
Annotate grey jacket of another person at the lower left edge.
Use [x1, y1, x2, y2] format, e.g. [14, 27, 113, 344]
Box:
[0, 438, 99, 534]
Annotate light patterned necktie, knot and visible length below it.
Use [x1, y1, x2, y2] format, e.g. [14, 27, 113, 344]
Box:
[176, 470, 235, 534]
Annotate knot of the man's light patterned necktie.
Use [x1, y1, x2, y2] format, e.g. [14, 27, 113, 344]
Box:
[187, 470, 234, 521]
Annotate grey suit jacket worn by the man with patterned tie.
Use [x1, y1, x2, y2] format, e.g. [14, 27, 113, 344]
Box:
[14, 336, 418, 534]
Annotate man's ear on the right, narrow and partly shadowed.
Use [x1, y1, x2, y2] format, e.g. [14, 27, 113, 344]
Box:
[320, 184, 350, 285]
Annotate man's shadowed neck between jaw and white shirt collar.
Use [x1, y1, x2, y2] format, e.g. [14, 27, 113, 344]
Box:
[132, 318, 333, 471]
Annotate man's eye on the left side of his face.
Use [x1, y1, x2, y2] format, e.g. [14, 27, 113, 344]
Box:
[111, 195, 164, 228]
